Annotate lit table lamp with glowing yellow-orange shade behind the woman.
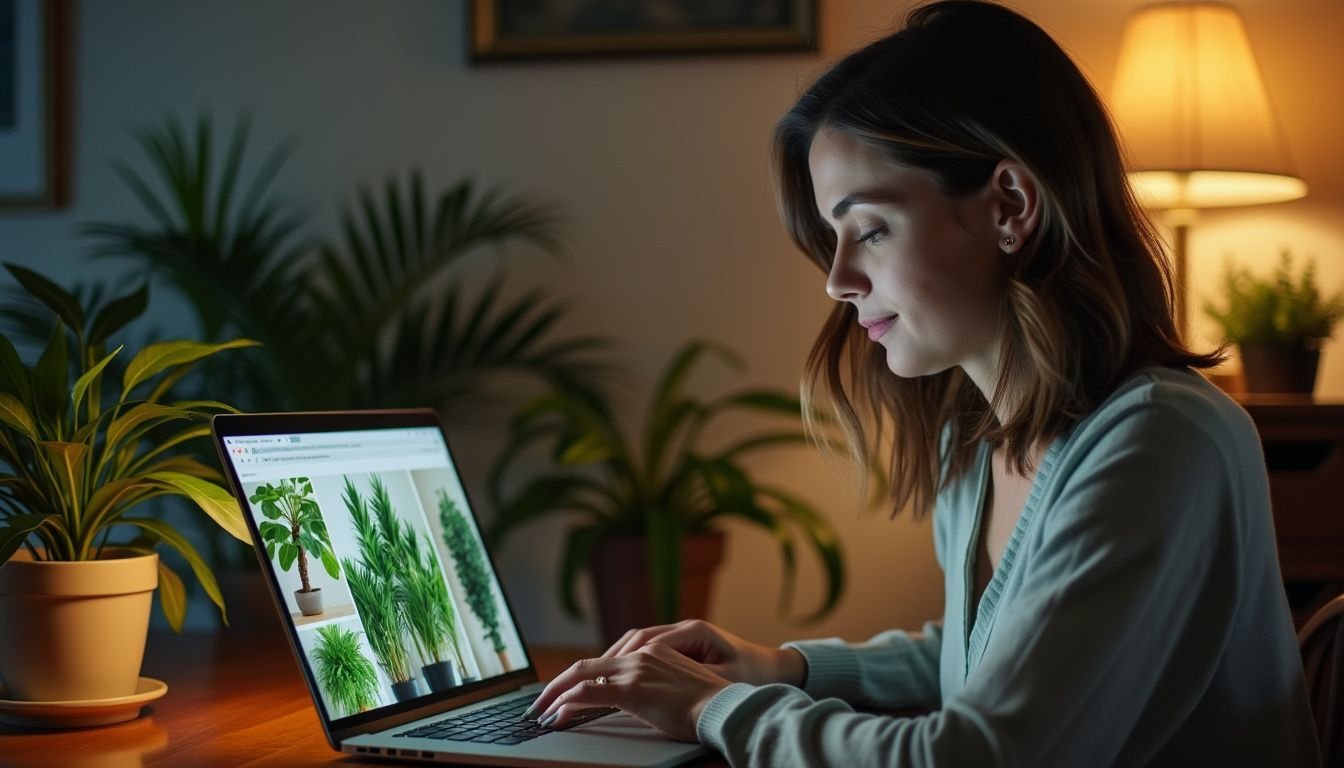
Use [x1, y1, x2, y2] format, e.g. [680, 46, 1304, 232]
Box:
[1110, 3, 1306, 336]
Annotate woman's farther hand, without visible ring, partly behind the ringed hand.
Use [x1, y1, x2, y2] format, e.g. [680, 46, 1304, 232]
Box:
[602, 619, 808, 686]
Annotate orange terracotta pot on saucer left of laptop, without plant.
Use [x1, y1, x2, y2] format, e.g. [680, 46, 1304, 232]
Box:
[0, 550, 159, 701]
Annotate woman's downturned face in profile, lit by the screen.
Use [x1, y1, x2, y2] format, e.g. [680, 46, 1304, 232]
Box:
[809, 129, 1007, 391]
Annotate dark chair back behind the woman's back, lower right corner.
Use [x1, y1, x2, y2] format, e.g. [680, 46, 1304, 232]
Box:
[1297, 594, 1344, 767]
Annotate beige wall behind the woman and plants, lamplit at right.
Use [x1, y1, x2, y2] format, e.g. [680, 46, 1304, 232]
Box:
[0, 0, 1344, 643]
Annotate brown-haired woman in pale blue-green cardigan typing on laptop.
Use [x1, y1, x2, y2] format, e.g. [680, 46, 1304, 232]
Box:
[521, 1, 1318, 767]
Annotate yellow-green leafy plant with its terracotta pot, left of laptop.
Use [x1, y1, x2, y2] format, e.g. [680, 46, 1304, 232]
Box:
[0, 264, 253, 701]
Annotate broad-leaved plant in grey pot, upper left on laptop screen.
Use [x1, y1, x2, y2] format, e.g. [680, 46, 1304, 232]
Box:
[247, 477, 340, 616]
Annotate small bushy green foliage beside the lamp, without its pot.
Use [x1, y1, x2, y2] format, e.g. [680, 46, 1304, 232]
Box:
[1204, 252, 1344, 347]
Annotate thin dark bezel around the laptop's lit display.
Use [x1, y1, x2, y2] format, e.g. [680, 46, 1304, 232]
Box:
[211, 409, 538, 749]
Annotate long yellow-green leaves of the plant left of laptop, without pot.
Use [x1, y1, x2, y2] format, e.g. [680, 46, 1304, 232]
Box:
[0, 264, 255, 631]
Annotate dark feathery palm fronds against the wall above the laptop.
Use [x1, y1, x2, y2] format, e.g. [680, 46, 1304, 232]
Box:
[85, 110, 603, 413]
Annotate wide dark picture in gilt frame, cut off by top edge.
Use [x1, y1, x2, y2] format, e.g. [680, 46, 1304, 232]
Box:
[468, 0, 817, 62]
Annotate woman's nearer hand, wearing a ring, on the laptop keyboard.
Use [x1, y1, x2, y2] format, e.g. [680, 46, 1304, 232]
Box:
[528, 643, 730, 741]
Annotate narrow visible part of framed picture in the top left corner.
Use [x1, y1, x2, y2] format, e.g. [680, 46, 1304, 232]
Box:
[0, 0, 71, 208]
